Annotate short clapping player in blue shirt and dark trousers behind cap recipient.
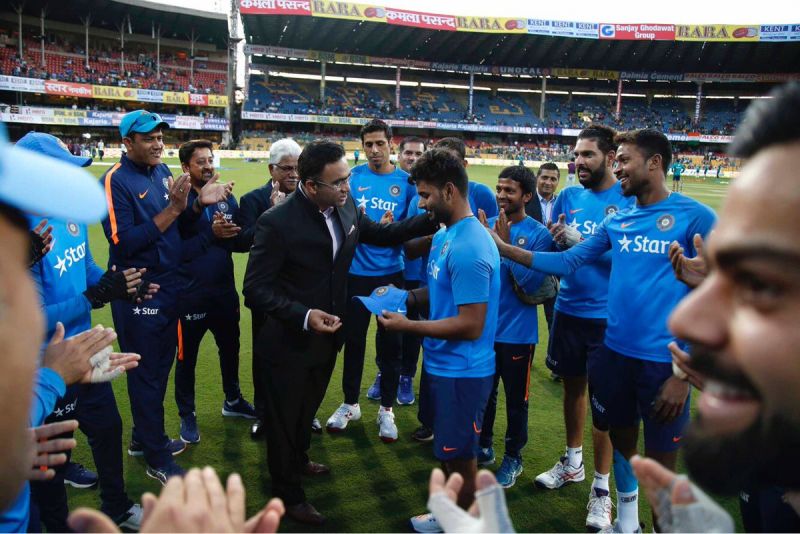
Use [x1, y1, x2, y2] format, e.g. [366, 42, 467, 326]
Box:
[478, 165, 555, 488]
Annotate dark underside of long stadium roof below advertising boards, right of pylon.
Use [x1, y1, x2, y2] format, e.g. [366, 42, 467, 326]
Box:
[242, 15, 800, 73]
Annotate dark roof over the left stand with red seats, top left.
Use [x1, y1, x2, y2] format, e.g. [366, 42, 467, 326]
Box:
[14, 0, 228, 49]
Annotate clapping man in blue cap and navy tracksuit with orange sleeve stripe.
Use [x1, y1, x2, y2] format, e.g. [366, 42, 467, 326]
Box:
[100, 110, 232, 484]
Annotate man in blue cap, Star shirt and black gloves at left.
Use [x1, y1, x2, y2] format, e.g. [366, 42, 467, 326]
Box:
[17, 132, 152, 532]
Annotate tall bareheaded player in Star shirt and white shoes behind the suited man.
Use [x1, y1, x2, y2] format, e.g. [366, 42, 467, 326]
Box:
[326, 119, 414, 443]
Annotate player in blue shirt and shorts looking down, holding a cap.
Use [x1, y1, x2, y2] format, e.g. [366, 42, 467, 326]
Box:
[378, 148, 500, 532]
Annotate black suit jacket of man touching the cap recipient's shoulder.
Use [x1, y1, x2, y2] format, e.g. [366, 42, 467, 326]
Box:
[244, 190, 437, 364]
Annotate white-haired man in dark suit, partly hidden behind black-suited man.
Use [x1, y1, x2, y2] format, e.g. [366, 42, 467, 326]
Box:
[236, 138, 304, 439]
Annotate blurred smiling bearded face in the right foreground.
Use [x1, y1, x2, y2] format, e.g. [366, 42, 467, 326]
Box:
[670, 142, 800, 492]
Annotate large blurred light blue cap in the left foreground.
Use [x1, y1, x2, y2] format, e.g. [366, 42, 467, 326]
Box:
[0, 123, 108, 224]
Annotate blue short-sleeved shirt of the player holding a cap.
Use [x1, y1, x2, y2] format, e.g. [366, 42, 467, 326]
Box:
[422, 217, 500, 378]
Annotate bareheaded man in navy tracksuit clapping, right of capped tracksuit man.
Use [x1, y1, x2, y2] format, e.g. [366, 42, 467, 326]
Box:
[175, 139, 256, 443]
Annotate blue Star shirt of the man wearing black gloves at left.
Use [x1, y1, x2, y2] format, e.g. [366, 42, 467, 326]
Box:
[31, 217, 104, 342]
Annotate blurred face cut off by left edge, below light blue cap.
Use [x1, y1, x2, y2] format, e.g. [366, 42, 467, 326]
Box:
[0, 214, 44, 509]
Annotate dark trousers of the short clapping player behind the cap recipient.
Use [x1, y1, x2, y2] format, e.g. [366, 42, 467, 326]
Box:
[480, 343, 536, 459]
